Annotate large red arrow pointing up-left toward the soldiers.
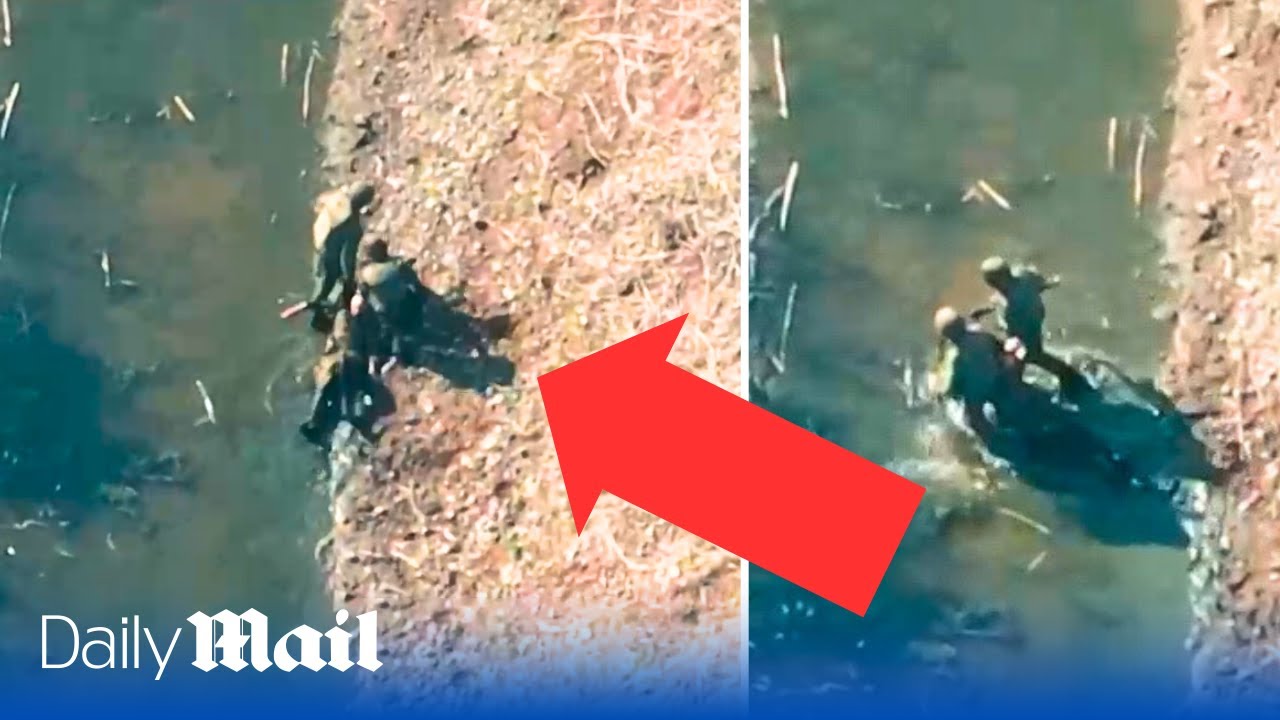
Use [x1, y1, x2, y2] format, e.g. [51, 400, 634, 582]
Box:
[538, 315, 924, 615]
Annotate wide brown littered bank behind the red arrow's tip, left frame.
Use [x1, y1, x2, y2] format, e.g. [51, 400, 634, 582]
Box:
[308, 0, 744, 702]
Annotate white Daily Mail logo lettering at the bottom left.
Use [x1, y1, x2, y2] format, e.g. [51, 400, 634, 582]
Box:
[40, 610, 383, 680]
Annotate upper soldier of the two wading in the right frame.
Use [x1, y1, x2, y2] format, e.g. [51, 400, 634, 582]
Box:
[974, 258, 1088, 393]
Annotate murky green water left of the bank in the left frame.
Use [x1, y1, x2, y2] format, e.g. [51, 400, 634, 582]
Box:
[0, 0, 345, 691]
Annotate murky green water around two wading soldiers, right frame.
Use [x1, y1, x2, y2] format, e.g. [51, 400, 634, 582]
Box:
[750, 0, 1189, 702]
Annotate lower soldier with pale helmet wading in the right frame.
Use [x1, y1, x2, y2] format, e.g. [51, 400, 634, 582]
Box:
[931, 307, 1021, 437]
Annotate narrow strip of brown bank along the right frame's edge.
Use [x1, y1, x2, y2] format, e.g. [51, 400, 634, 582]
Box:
[1164, 0, 1280, 697]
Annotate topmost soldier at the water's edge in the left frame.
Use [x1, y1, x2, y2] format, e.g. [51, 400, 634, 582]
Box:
[307, 183, 374, 324]
